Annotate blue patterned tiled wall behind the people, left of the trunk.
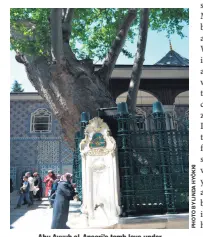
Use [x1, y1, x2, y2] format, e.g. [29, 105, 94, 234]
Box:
[10, 100, 73, 188]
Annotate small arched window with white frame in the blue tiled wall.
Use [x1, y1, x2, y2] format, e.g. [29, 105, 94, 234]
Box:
[30, 109, 52, 133]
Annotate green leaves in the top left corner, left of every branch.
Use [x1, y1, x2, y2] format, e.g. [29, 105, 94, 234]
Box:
[10, 8, 50, 55]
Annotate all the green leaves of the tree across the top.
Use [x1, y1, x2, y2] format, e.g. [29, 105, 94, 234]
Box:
[10, 8, 189, 61]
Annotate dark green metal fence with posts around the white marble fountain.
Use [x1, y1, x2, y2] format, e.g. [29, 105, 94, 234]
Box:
[74, 103, 189, 216]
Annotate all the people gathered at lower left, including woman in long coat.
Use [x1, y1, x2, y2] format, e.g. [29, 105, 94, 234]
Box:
[12, 170, 76, 229]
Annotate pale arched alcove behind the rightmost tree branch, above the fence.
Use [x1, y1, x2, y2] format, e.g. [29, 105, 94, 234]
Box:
[116, 90, 158, 106]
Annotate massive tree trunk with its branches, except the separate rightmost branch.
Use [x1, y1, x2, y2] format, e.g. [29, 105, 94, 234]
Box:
[13, 8, 137, 147]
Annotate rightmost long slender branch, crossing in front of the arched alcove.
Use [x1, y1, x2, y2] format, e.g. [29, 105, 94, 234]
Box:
[127, 8, 149, 112]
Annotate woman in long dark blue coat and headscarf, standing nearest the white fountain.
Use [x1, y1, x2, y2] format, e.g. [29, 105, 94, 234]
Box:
[51, 173, 75, 229]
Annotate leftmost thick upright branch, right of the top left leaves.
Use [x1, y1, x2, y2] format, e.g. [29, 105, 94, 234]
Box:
[50, 8, 64, 64]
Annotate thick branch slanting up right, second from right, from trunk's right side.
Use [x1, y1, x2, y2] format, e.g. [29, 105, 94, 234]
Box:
[98, 9, 137, 86]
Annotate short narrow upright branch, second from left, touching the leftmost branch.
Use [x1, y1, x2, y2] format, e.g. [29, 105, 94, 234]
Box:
[62, 8, 74, 43]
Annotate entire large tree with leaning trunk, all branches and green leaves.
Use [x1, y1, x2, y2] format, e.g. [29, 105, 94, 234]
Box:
[10, 8, 189, 144]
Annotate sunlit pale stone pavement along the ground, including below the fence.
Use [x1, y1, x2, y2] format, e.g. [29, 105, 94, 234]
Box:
[10, 192, 189, 230]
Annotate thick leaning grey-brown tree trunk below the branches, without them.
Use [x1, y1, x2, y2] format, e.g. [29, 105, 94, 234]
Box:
[24, 57, 115, 146]
